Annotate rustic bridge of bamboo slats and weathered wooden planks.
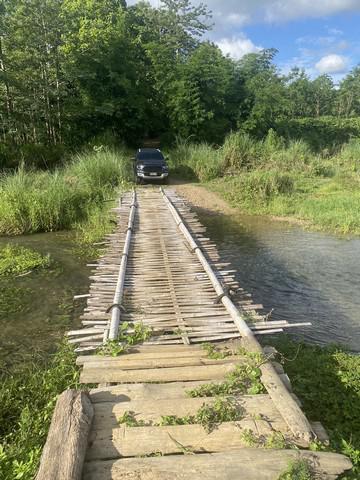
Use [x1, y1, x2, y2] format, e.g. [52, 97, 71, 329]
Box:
[37, 187, 351, 480]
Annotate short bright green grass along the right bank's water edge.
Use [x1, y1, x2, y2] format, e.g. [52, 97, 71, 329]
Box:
[208, 171, 360, 234]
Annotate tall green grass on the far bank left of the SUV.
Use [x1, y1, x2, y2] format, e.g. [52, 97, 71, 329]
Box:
[0, 150, 130, 235]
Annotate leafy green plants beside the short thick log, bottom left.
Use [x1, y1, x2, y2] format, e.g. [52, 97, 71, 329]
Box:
[0, 343, 79, 480]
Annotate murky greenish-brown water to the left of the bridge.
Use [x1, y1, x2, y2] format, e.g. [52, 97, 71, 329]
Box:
[0, 233, 89, 366]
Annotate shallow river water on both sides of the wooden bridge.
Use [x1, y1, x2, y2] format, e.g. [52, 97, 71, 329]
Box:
[0, 211, 360, 366]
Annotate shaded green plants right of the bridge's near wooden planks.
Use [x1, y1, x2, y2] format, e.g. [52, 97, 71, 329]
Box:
[275, 339, 360, 480]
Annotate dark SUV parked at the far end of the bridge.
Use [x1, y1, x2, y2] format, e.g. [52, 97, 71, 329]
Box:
[134, 148, 169, 183]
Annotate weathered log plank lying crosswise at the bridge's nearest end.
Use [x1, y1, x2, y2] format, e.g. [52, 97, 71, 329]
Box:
[84, 448, 352, 480]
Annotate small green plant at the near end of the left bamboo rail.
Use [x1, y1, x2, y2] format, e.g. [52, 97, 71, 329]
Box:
[97, 322, 152, 357]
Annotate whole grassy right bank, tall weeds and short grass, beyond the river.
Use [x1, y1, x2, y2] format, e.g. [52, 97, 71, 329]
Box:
[170, 131, 360, 234]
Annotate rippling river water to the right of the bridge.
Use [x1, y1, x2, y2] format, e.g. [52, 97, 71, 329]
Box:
[199, 212, 360, 352]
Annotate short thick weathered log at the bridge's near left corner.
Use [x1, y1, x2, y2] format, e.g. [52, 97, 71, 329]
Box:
[36, 390, 94, 480]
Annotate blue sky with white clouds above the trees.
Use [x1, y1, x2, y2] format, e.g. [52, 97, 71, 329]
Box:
[128, 0, 360, 82]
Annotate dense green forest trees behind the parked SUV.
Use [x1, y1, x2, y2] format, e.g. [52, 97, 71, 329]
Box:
[0, 0, 360, 168]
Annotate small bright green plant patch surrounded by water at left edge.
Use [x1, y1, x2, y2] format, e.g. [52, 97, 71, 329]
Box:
[0, 244, 50, 276]
